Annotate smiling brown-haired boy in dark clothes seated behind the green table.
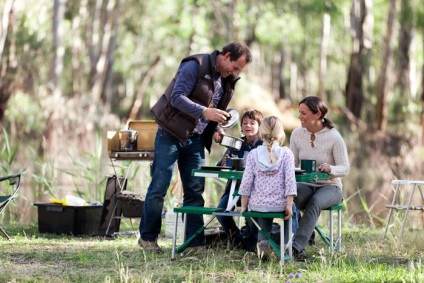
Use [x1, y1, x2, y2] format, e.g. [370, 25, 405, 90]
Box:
[217, 110, 263, 251]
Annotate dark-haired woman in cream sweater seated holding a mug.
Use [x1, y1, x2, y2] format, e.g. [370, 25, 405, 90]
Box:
[290, 96, 350, 261]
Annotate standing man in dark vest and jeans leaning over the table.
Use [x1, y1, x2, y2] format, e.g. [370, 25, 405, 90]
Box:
[138, 43, 252, 253]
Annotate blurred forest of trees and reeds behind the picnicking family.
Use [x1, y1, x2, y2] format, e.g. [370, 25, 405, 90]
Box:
[0, 0, 424, 227]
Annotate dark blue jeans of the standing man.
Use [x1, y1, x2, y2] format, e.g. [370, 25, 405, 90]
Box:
[140, 129, 205, 246]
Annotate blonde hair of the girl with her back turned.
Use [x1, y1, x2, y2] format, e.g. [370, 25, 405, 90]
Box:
[259, 116, 286, 163]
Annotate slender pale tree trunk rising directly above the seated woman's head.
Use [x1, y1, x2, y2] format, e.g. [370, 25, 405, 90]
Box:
[317, 13, 331, 100]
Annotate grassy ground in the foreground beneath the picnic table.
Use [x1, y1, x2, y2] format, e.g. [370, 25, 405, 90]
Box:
[0, 224, 424, 282]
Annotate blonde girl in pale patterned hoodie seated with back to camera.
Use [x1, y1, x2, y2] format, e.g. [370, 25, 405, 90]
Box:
[239, 116, 297, 258]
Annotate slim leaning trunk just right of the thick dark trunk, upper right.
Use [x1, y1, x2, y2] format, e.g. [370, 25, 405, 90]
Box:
[375, 0, 396, 130]
